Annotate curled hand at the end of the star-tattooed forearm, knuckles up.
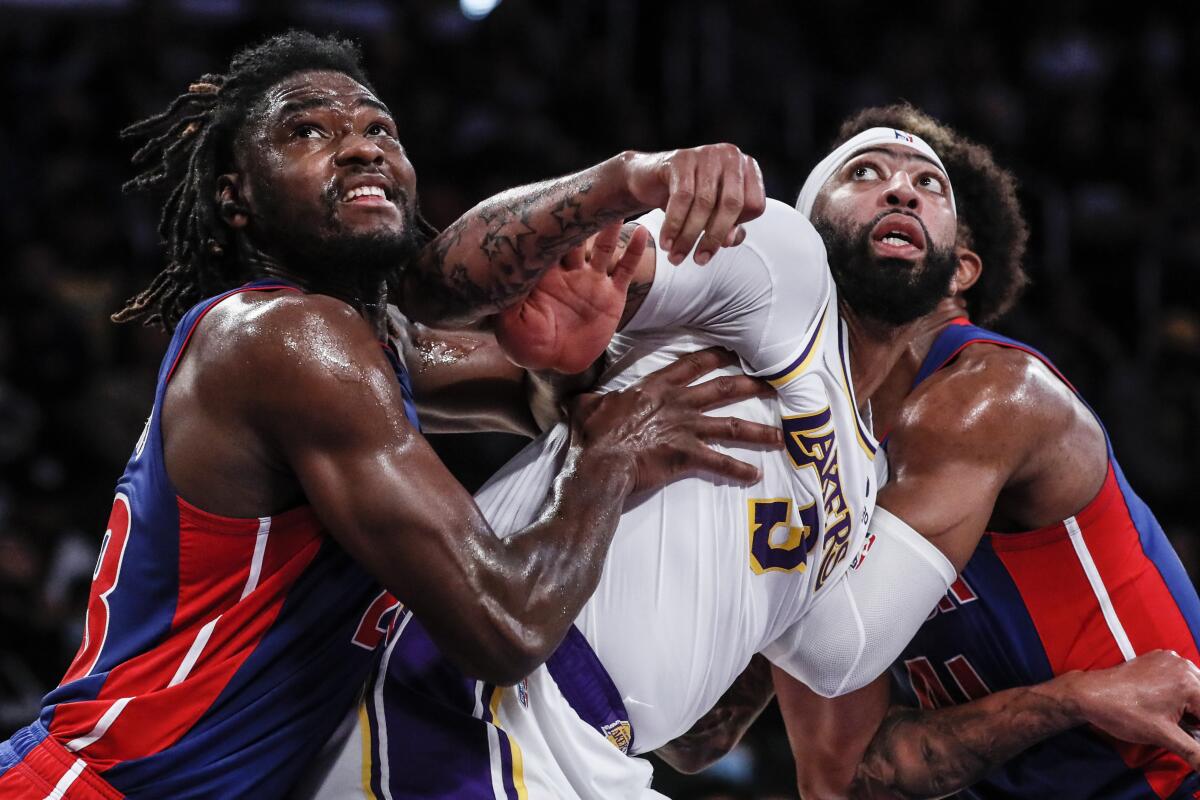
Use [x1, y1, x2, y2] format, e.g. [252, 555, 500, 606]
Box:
[626, 144, 767, 265]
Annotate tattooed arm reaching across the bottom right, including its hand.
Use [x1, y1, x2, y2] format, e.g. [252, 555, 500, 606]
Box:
[775, 650, 1200, 800]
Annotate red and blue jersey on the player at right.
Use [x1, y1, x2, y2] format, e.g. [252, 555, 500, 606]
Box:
[893, 324, 1200, 800]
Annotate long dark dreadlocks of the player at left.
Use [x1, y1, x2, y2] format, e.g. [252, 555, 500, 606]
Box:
[112, 30, 437, 331]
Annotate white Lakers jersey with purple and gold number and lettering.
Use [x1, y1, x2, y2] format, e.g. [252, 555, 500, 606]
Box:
[476, 200, 883, 752]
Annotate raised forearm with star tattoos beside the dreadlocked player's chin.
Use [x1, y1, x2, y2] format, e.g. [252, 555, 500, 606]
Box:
[400, 152, 649, 325]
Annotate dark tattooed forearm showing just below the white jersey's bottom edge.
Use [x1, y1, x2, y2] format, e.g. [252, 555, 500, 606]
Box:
[654, 655, 775, 775]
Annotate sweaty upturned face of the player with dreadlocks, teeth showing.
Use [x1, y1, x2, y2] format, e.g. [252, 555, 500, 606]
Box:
[225, 71, 416, 280]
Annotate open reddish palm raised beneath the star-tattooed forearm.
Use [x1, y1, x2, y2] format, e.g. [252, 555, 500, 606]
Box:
[496, 222, 649, 374]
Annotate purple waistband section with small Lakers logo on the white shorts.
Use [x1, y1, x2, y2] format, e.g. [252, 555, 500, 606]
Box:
[546, 625, 634, 754]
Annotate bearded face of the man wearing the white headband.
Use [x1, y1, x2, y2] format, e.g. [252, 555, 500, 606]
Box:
[812, 145, 958, 325]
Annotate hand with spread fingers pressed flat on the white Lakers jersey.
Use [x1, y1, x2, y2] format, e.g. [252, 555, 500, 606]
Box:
[570, 348, 784, 493]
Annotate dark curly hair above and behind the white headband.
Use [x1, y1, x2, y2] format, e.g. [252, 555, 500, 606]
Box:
[834, 103, 1030, 325]
